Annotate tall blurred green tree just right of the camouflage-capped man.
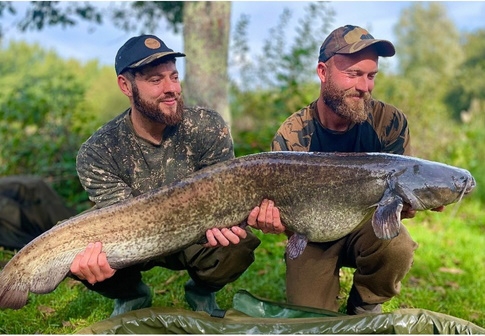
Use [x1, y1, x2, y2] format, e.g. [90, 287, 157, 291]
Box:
[394, 2, 464, 142]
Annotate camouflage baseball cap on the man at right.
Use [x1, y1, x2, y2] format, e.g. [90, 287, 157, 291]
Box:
[318, 25, 396, 62]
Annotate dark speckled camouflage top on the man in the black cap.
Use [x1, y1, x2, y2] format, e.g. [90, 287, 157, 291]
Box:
[76, 107, 234, 208]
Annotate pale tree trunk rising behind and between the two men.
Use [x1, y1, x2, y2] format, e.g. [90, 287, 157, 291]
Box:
[183, 1, 231, 124]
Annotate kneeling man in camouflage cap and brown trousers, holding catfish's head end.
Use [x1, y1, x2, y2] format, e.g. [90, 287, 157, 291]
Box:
[248, 25, 442, 315]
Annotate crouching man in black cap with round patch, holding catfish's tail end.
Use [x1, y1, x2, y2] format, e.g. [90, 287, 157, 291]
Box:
[71, 35, 260, 316]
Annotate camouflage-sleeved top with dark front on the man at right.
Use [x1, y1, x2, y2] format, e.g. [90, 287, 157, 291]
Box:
[271, 100, 411, 155]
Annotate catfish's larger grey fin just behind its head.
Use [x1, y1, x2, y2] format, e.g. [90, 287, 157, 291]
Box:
[372, 196, 403, 239]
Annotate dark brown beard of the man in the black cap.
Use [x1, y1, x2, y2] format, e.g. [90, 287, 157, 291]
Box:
[132, 83, 184, 126]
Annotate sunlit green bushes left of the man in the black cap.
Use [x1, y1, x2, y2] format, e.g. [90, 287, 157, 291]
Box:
[0, 42, 126, 210]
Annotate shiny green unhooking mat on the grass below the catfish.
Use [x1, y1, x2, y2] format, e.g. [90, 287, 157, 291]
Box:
[78, 291, 485, 334]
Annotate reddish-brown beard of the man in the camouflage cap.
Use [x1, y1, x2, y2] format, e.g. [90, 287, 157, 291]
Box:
[322, 80, 372, 124]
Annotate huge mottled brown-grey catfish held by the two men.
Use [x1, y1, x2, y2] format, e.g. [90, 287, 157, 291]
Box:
[0, 152, 475, 309]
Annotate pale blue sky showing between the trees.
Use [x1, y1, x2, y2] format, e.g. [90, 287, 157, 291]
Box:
[3, 1, 485, 76]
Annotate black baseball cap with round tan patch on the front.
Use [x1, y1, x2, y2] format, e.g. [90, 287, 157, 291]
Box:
[115, 35, 185, 75]
